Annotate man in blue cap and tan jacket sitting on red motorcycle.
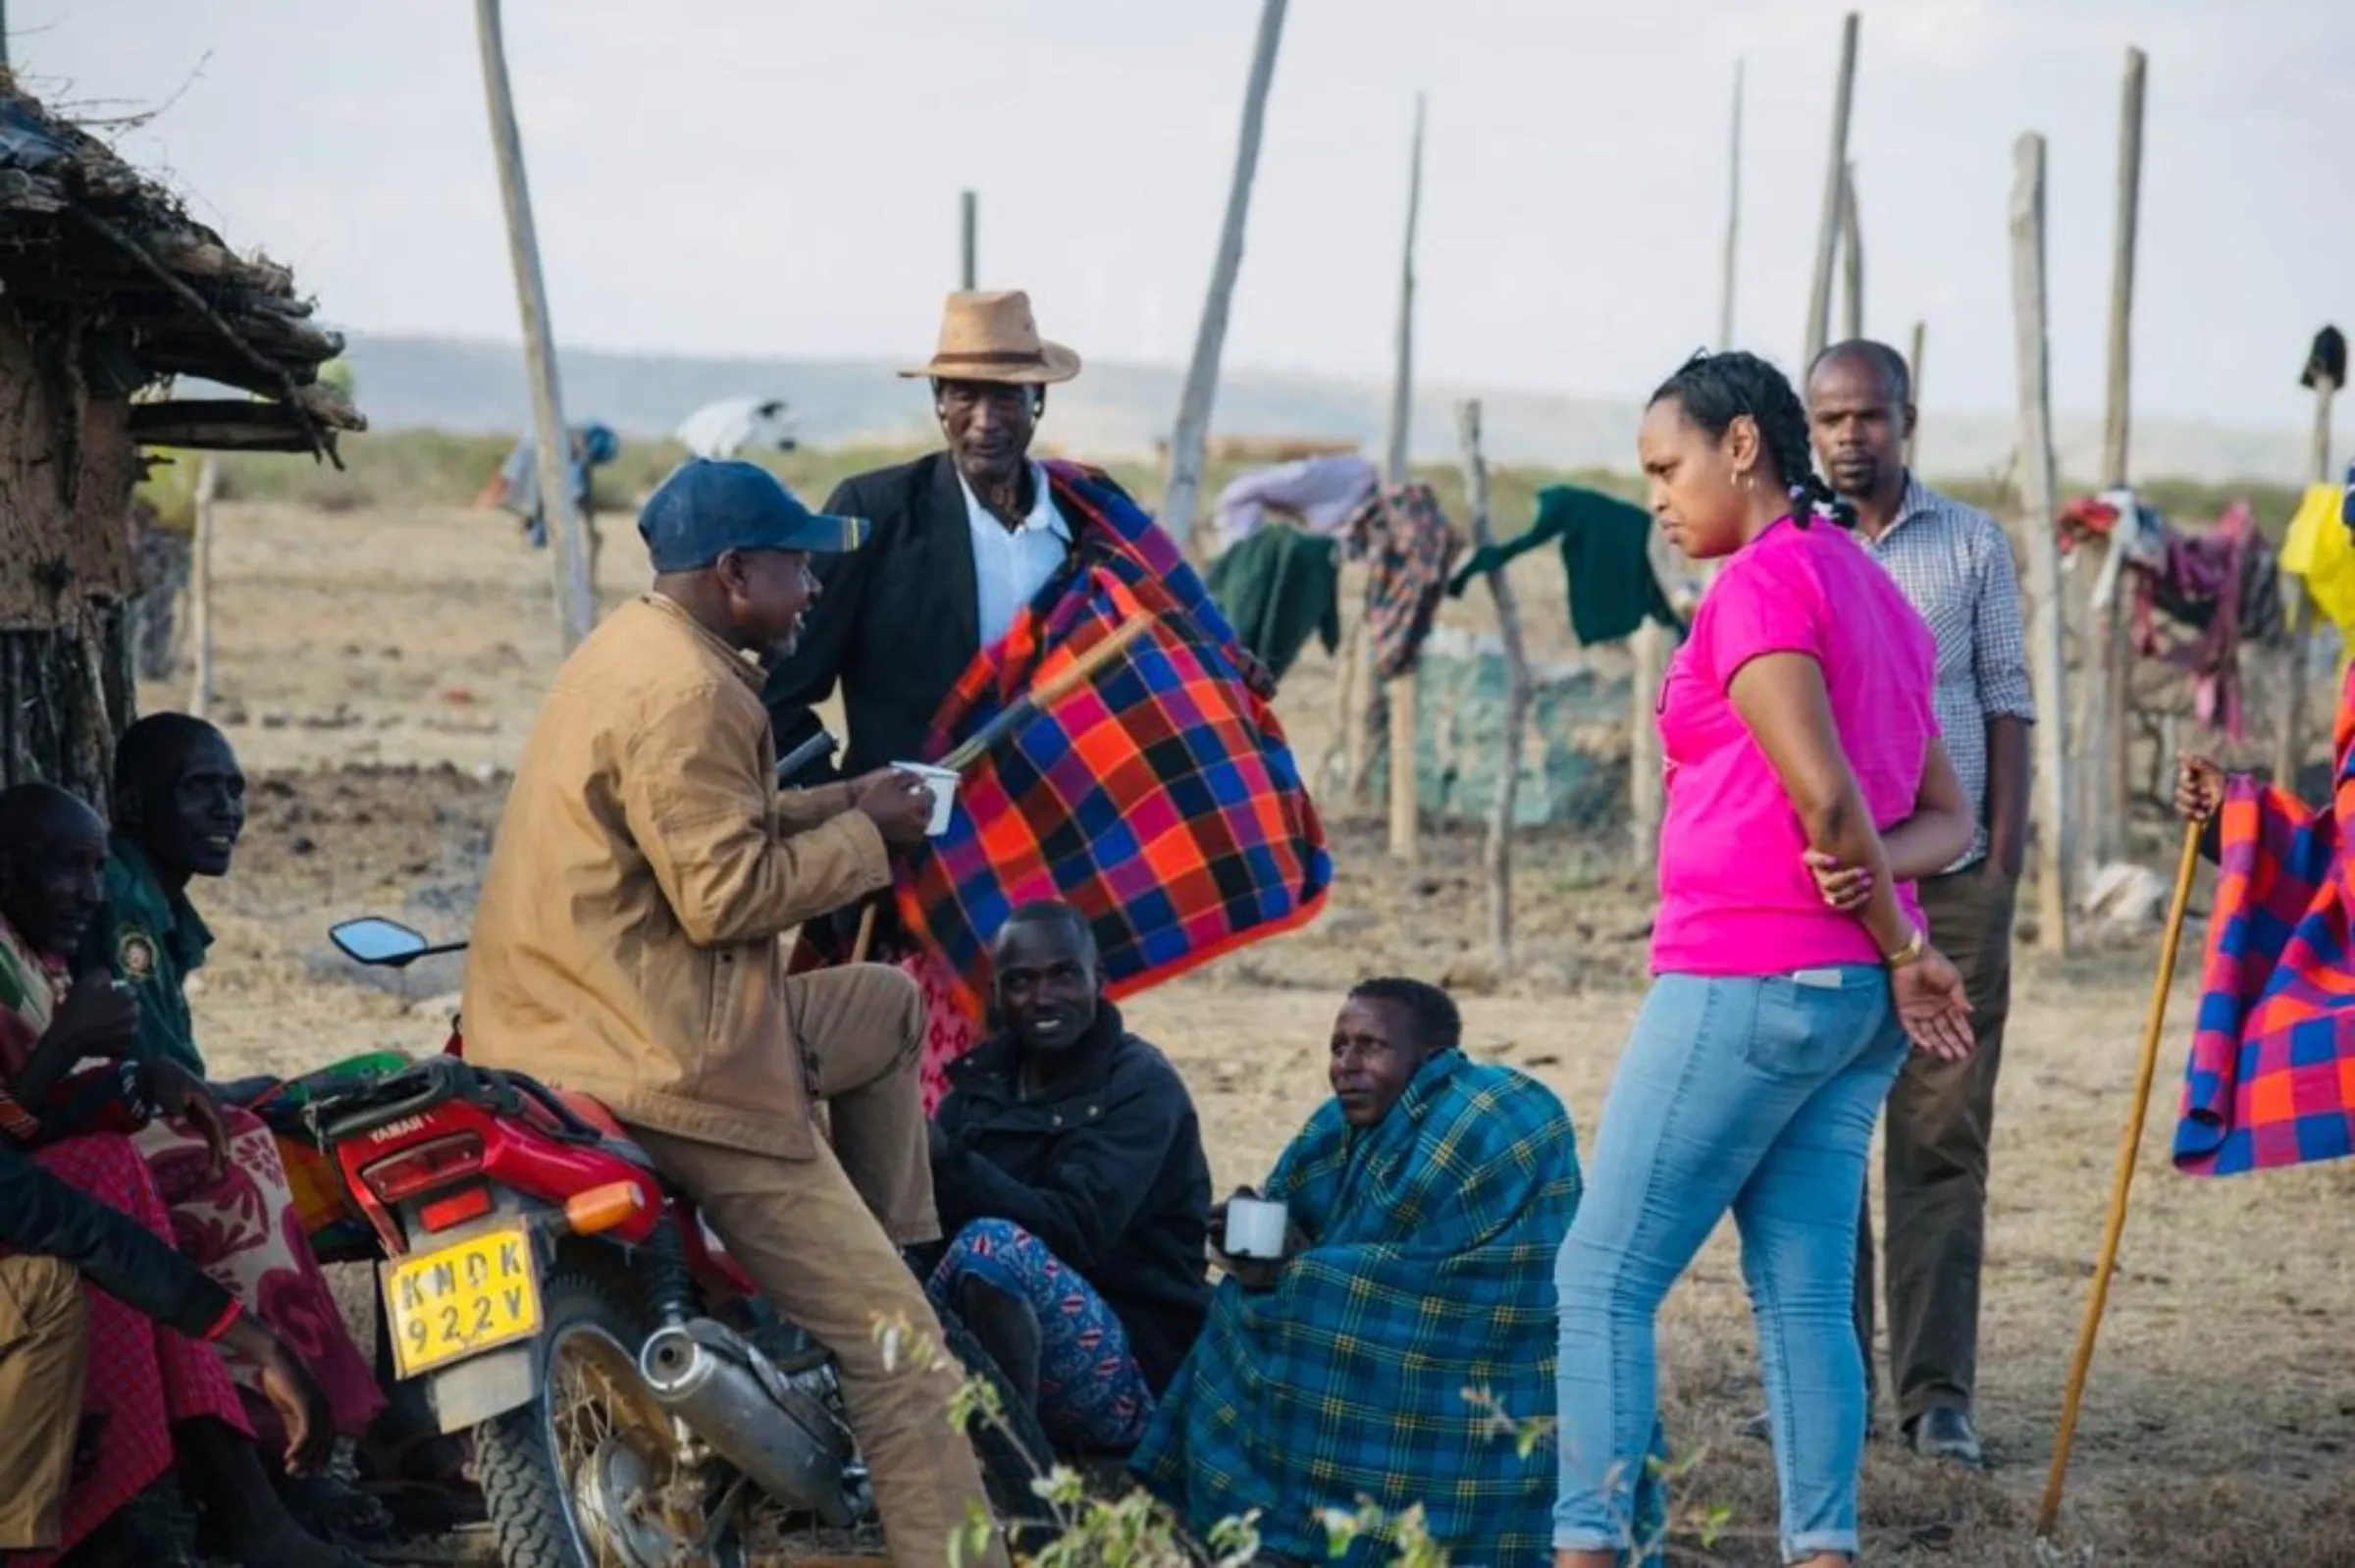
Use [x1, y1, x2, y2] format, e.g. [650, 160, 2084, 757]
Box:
[466, 459, 1003, 1568]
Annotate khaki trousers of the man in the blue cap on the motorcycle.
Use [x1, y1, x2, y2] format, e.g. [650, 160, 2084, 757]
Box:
[631, 966, 1006, 1568]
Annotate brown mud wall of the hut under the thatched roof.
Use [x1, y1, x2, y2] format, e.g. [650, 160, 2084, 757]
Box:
[0, 304, 139, 801]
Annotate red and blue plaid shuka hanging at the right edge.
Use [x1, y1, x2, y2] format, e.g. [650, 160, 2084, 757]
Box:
[2176, 678, 2355, 1175]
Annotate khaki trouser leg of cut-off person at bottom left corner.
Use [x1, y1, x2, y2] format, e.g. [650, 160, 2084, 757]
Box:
[0, 1255, 89, 1551]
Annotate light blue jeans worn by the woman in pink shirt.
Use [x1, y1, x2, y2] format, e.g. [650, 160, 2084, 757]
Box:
[1554, 966, 1906, 1561]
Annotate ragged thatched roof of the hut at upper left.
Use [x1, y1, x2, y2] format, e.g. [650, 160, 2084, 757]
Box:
[0, 73, 367, 459]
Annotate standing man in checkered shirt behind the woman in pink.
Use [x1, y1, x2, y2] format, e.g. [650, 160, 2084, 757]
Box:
[1806, 341, 2035, 1469]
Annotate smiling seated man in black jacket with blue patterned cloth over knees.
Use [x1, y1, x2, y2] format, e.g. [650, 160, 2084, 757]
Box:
[932, 904, 1211, 1452]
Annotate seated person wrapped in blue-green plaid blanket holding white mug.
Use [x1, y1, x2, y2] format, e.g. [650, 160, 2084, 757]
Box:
[1130, 979, 1665, 1568]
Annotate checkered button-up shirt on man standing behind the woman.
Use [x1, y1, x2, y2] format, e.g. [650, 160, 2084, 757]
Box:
[1858, 473, 2037, 871]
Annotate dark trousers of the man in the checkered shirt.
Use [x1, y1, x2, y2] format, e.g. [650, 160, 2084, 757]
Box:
[1856, 864, 2015, 1422]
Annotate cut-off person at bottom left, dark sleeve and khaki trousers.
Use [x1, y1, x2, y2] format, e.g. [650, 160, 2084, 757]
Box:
[0, 1144, 335, 1561]
